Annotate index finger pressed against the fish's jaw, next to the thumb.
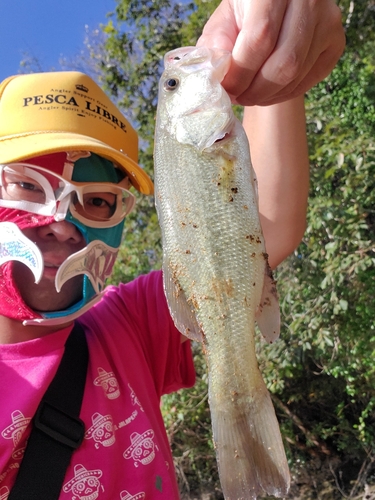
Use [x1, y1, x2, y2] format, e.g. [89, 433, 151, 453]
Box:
[223, 0, 287, 98]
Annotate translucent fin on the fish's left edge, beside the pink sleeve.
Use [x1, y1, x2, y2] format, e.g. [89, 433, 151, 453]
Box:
[163, 265, 203, 342]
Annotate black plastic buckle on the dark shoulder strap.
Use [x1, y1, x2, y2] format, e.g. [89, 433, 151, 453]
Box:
[34, 400, 85, 450]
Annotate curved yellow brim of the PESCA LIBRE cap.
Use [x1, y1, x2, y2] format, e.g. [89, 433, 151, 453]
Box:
[0, 131, 154, 194]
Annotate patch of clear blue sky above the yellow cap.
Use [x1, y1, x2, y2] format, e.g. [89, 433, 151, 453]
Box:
[0, 0, 116, 81]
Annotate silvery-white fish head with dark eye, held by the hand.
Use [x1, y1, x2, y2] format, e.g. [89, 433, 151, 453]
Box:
[157, 47, 234, 151]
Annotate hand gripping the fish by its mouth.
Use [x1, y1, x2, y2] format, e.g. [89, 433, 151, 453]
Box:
[197, 0, 345, 106]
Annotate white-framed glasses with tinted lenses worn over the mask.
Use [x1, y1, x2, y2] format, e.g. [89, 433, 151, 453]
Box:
[0, 163, 135, 228]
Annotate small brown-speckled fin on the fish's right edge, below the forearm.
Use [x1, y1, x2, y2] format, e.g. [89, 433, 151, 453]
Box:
[255, 265, 280, 343]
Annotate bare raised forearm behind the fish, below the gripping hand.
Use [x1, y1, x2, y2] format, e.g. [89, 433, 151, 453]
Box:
[243, 96, 309, 268]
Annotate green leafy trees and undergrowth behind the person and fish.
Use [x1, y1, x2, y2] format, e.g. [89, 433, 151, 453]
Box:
[83, 0, 375, 500]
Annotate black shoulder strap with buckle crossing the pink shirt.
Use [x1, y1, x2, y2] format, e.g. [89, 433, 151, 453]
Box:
[8, 322, 88, 500]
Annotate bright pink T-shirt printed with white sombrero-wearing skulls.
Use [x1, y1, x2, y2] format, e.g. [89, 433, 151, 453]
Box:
[0, 272, 195, 500]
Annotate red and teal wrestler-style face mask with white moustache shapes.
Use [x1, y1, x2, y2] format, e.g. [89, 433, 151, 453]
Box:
[0, 152, 134, 325]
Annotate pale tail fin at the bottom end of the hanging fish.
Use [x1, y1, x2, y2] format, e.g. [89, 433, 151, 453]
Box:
[210, 373, 290, 500]
